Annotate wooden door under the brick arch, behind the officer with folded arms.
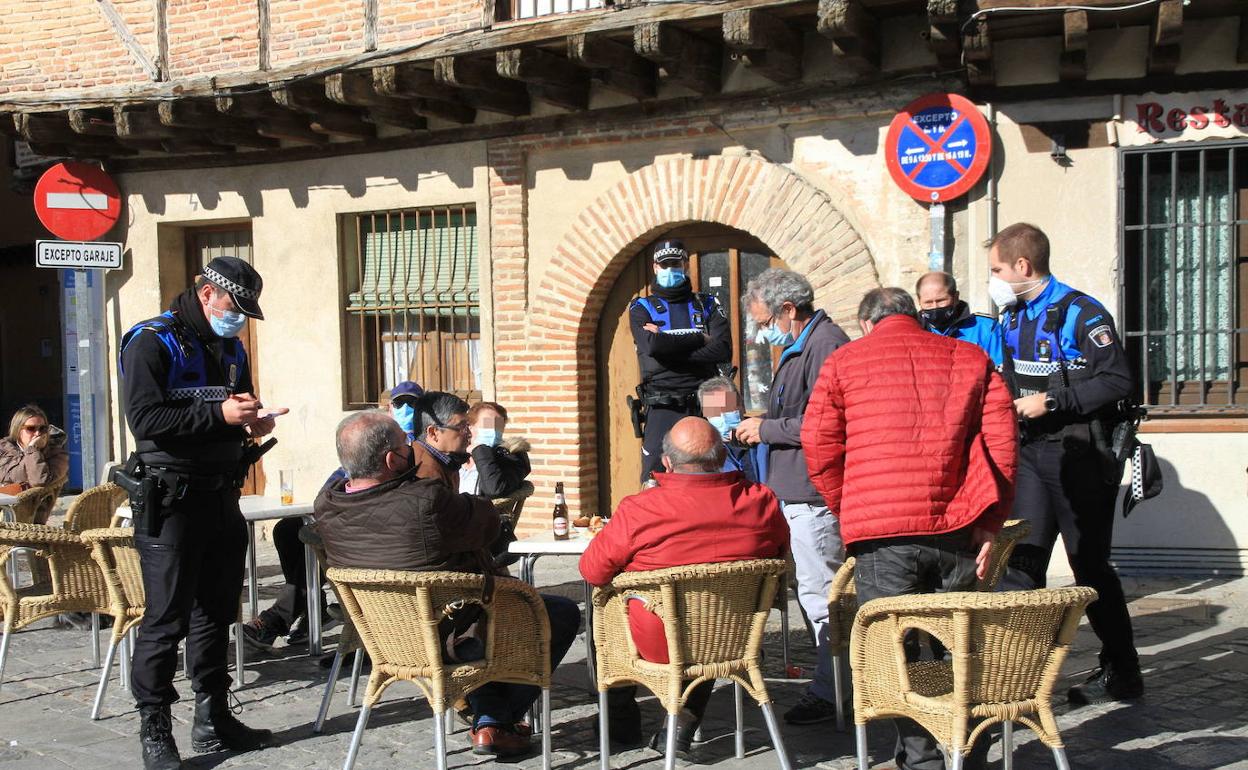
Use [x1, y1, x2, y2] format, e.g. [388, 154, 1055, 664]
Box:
[597, 225, 784, 513]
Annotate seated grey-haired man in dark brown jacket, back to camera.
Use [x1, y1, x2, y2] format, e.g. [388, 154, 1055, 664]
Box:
[314, 412, 580, 756]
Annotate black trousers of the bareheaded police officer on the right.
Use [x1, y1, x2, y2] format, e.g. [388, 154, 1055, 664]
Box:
[1001, 441, 1139, 669]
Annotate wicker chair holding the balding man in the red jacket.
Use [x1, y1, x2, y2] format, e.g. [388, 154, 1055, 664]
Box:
[593, 559, 790, 770]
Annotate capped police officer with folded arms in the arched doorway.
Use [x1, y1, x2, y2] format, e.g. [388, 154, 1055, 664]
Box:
[628, 241, 733, 482]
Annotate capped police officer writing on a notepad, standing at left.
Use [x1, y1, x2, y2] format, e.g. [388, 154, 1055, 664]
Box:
[121, 257, 286, 770]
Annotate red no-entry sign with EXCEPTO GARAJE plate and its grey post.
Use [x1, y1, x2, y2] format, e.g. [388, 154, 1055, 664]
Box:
[35, 161, 121, 489]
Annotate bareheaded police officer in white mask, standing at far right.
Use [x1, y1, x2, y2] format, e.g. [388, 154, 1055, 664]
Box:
[988, 223, 1143, 705]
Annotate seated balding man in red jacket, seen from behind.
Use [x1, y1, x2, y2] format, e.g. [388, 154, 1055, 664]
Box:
[580, 417, 789, 756]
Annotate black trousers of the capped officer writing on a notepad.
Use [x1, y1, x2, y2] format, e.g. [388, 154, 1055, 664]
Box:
[130, 488, 247, 706]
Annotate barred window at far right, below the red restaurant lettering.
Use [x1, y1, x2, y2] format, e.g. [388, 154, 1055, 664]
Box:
[1121, 142, 1248, 414]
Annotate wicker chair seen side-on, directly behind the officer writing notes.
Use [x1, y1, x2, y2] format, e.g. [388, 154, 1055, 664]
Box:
[81, 528, 145, 719]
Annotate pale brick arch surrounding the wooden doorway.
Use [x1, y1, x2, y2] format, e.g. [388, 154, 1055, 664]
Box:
[495, 155, 880, 525]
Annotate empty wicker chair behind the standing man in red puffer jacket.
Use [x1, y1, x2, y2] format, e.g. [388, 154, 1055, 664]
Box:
[850, 588, 1096, 770]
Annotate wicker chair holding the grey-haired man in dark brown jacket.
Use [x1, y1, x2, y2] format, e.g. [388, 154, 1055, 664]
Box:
[328, 568, 550, 770]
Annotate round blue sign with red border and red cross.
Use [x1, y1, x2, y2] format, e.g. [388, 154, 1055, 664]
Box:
[884, 94, 992, 203]
